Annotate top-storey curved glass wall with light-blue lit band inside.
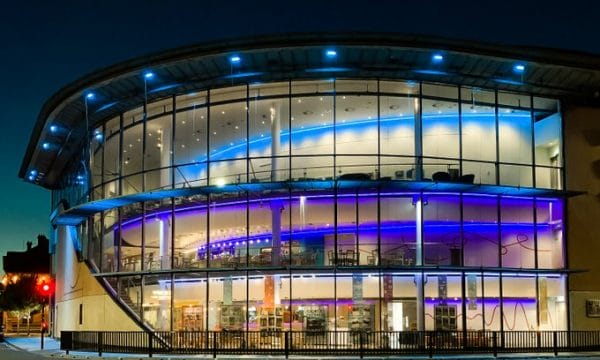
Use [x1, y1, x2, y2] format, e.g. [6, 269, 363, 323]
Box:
[84, 79, 562, 204]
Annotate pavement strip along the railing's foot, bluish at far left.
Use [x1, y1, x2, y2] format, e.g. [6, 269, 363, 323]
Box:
[5, 334, 600, 360]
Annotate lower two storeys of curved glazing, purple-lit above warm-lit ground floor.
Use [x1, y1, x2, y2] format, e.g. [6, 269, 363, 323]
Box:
[88, 189, 566, 332]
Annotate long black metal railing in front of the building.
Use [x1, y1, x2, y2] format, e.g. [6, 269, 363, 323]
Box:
[60, 331, 600, 358]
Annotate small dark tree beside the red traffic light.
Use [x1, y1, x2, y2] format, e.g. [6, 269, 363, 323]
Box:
[0, 275, 45, 334]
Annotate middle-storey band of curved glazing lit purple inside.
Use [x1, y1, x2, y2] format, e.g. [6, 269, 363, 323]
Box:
[96, 189, 564, 272]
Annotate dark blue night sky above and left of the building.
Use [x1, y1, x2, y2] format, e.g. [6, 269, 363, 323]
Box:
[0, 0, 600, 268]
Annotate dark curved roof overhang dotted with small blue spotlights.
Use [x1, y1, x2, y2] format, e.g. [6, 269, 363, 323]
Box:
[19, 33, 600, 189]
